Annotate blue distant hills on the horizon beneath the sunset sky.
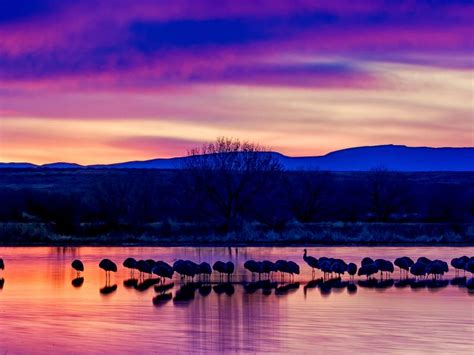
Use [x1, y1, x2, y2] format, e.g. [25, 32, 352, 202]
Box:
[0, 145, 474, 171]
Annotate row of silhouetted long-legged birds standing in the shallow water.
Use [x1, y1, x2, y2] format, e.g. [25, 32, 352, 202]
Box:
[0, 253, 474, 281]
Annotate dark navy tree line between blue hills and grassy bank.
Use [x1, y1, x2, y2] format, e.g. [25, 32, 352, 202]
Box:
[0, 138, 474, 233]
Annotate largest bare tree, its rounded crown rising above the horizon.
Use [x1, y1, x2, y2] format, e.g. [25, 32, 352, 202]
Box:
[184, 137, 282, 228]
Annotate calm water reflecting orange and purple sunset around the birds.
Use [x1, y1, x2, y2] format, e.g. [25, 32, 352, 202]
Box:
[0, 247, 474, 354]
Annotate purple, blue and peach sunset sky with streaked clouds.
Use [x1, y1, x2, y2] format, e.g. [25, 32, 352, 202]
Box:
[0, 0, 474, 164]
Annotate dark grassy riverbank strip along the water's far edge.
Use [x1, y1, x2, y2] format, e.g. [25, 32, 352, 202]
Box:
[0, 222, 474, 246]
